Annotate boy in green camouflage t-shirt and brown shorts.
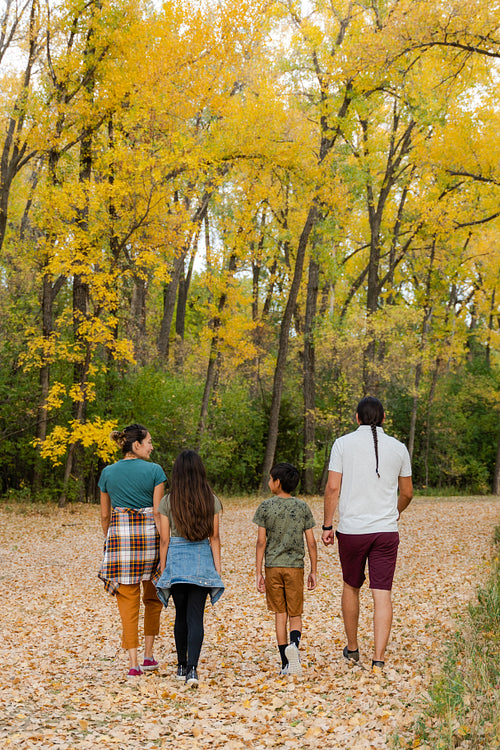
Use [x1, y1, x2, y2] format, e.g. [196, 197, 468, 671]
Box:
[253, 463, 317, 674]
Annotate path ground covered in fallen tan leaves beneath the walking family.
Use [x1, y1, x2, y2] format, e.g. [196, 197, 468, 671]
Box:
[0, 498, 500, 750]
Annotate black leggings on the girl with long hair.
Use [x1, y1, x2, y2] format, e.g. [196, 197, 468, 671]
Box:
[172, 583, 208, 667]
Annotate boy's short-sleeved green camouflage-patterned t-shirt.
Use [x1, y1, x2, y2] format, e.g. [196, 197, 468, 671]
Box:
[253, 497, 316, 568]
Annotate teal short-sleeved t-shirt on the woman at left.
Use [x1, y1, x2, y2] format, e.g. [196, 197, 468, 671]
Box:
[99, 458, 167, 508]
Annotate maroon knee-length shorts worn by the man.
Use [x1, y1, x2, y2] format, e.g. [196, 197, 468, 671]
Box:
[337, 531, 399, 591]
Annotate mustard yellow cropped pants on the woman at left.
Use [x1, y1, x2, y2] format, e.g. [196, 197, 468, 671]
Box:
[115, 581, 163, 649]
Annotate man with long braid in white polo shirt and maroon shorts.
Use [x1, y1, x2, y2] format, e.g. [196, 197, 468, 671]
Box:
[322, 396, 413, 669]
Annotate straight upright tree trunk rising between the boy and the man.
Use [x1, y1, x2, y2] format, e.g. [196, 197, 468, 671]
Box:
[302, 258, 319, 495]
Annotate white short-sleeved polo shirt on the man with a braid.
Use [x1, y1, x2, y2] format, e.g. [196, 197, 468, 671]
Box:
[328, 425, 411, 534]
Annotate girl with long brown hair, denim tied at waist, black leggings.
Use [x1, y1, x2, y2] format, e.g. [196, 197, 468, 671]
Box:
[156, 450, 224, 686]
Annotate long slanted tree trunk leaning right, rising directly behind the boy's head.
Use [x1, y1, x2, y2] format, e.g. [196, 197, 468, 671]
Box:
[260, 202, 319, 494]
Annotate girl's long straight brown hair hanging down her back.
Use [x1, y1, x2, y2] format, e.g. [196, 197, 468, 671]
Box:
[170, 450, 215, 542]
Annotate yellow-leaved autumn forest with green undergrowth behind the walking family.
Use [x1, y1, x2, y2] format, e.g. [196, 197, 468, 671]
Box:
[0, 0, 500, 505]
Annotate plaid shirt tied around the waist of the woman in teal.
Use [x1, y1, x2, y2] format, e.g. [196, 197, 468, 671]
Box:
[97, 508, 160, 594]
